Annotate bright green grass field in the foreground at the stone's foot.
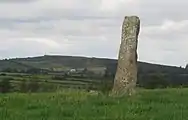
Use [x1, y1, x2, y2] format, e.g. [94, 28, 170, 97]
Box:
[0, 89, 188, 120]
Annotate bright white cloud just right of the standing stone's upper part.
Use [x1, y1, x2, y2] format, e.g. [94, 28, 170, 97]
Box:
[142, 20, 188, 41]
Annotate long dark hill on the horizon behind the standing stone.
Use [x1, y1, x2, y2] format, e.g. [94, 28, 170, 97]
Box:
[0, 55, 188, 88]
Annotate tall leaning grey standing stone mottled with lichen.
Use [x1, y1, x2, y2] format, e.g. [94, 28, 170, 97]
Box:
[112, 16, 140, 96]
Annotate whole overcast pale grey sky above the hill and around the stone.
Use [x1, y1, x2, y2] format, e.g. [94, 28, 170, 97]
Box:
[0, 0, 188, 66]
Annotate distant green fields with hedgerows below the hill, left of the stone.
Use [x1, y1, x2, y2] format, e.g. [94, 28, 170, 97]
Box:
[0, 73, 113, 93]
